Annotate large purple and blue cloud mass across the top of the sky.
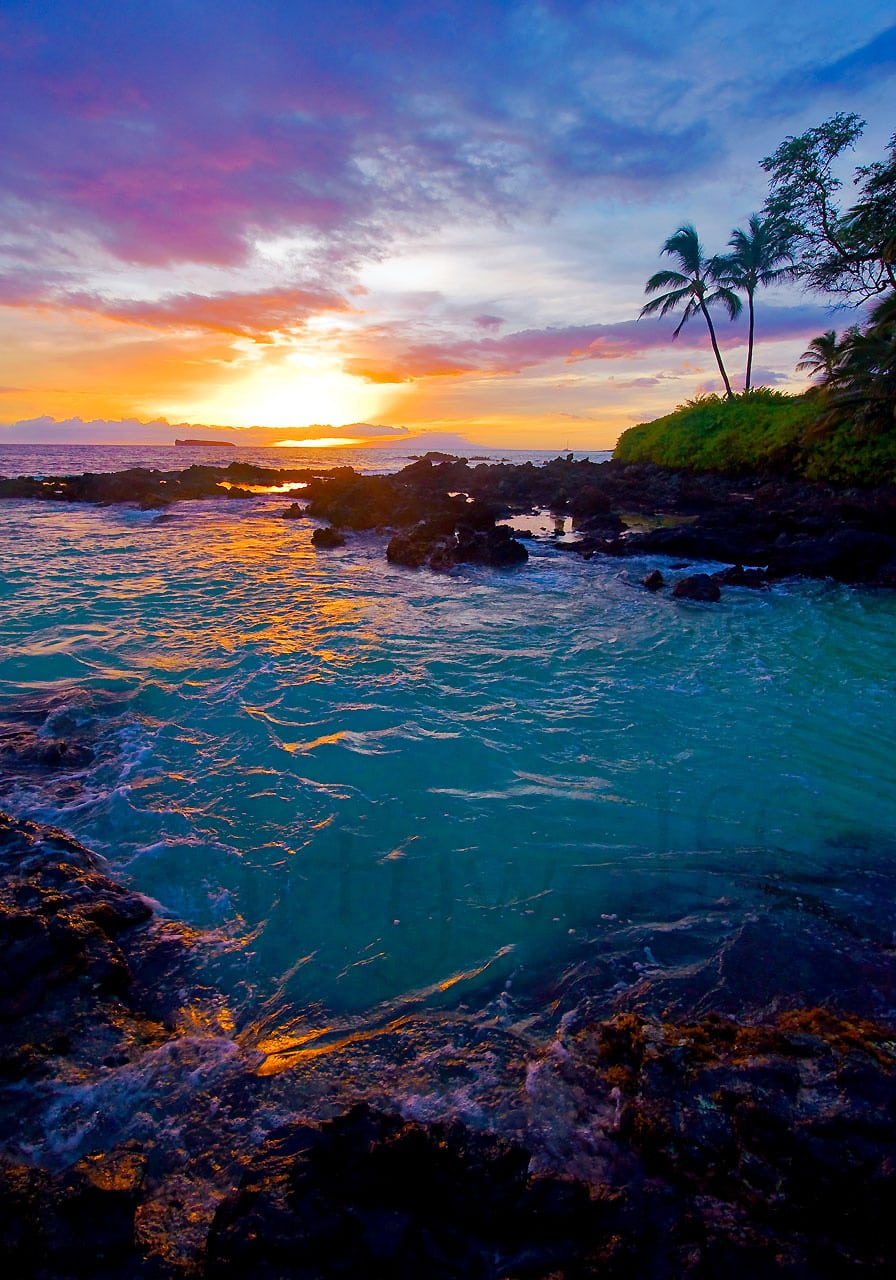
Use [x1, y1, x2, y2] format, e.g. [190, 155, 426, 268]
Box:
[0, 0, 778, 282]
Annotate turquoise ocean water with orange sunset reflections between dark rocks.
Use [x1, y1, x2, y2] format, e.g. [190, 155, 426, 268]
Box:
[0, 447, 896, 1233]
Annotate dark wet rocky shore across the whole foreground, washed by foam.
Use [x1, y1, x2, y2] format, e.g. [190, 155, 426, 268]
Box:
[0, 815, 896, 1280]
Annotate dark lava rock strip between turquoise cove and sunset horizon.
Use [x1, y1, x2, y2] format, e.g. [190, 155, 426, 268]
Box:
[0, 454, 896, 586]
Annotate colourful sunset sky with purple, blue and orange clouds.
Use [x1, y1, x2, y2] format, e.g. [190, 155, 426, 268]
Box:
[0, 0, 896, 449]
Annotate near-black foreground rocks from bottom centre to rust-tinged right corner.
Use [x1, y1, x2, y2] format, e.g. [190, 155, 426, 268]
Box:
[199, 1009, 896, 1280]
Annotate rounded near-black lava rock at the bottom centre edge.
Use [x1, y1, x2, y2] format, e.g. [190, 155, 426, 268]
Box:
[206, 1105, 602, 1280]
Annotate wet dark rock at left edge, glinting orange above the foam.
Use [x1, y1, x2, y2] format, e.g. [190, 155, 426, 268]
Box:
[0, 813, 222, 1082]
